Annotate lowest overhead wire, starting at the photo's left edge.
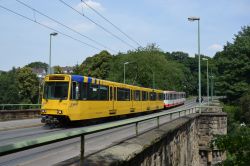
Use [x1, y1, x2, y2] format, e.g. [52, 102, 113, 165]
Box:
[0, 5, 102, 51]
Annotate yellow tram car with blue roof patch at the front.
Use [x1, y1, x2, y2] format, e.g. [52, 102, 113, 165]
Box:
[41, 74, 164, 124]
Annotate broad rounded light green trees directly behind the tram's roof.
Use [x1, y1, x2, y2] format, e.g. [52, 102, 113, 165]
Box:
[108, 45, 188, 90]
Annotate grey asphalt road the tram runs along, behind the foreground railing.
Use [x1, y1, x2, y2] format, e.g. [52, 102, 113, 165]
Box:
[0, 100, 197, 166]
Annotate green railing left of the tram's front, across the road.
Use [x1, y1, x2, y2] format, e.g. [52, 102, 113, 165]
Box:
[0, 104, 41, 110]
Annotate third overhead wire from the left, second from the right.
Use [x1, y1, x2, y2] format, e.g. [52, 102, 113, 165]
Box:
[59, 0, 136, 49]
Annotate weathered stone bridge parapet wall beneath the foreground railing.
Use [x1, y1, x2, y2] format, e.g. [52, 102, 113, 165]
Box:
[58, 107, 227, 166]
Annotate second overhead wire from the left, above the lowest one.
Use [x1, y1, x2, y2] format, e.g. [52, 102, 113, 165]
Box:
[16, 0, 116, 52]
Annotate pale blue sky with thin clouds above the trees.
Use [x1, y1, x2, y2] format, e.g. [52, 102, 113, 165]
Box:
[0, 0, 250, 71]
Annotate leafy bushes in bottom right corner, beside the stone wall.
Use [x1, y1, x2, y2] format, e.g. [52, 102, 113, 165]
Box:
[212, 101, 250, 166]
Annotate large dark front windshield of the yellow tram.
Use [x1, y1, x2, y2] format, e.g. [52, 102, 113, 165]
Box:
[43, 82, 69, 100]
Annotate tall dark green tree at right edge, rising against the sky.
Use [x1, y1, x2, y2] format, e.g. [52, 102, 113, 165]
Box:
[214, 26, 250, 101]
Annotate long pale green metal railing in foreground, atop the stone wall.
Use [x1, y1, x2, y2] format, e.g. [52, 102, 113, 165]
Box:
[0, 106, 211, 163]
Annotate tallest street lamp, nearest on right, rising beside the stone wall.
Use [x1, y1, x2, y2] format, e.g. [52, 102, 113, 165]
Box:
[188, 17, 201, 106]
